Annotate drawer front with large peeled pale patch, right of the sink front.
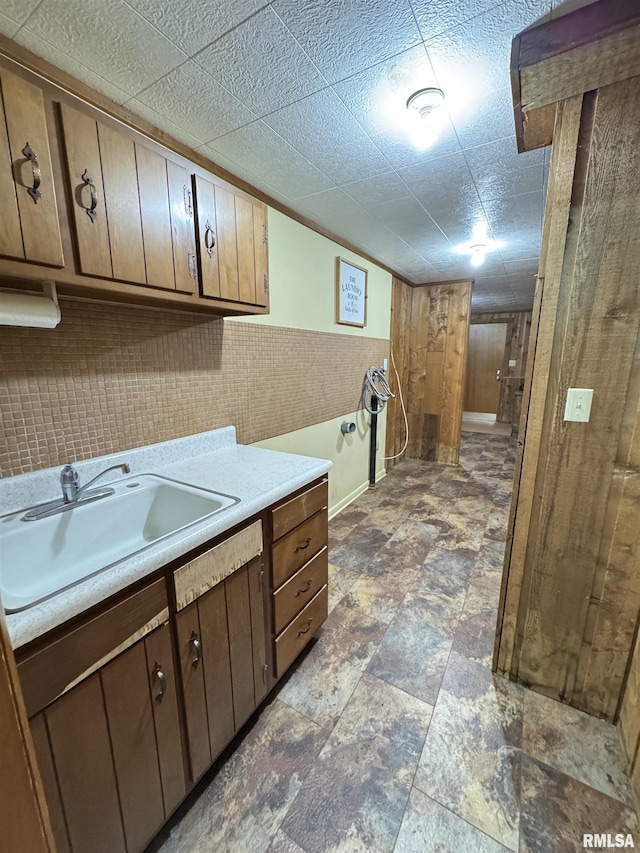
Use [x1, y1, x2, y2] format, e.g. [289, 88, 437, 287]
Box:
[173, 521, 262, 610]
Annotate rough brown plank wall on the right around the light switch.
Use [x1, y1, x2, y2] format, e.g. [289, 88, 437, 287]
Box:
[495, 79, 640, 720]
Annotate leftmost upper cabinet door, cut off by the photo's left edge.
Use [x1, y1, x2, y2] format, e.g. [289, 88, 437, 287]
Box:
[0, 70, 64, 267]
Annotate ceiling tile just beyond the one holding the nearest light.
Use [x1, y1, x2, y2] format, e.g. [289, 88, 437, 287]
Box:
[398, 151, 478, 212]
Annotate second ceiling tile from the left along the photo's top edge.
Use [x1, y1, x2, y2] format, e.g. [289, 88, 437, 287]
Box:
[21, 0, 187, 97]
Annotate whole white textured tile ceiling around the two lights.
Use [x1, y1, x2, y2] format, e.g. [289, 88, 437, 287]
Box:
[0, 0, 580, 311]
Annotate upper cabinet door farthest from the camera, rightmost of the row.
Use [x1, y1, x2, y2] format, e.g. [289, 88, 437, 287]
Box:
[194, 175, 269, 306]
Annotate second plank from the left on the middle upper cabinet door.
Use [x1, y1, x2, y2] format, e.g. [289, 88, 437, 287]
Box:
[98, 124, 147, 284]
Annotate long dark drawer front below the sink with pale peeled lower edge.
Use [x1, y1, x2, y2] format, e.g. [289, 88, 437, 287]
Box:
[18, 580, 169, 717]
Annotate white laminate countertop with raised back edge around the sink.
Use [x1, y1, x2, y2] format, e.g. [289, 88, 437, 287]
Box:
[0, 427, 332, 649]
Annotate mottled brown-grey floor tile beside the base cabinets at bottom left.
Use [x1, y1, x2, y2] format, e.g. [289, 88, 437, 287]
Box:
[154, 700, 327, 853]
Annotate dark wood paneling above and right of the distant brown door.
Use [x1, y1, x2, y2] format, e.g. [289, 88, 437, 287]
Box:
[471, 311, 531, 426]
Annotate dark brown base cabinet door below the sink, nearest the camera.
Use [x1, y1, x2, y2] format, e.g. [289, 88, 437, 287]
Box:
[32, 624, 185, 853]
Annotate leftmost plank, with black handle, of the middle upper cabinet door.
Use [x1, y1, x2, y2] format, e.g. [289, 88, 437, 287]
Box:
[60, 104, 113, 278]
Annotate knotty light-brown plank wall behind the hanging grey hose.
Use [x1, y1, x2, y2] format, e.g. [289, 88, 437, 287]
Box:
[386, 279, 471, 465]
